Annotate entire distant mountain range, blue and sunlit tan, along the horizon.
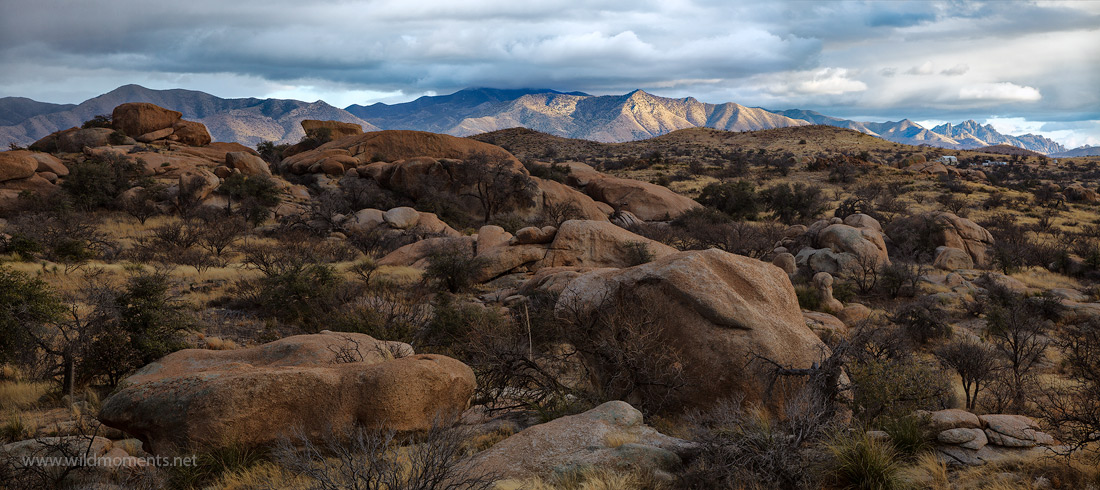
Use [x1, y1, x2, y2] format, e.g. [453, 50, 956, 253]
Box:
[0, 85, 1073, 156]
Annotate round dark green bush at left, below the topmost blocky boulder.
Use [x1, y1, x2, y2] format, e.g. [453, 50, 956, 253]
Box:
[62, 153, 143, 210]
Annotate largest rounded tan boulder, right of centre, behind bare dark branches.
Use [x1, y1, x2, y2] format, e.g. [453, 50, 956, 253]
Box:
[556, 247, 827, 410]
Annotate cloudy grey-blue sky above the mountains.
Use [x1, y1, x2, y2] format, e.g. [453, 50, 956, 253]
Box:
[0, 0, 1100, 148]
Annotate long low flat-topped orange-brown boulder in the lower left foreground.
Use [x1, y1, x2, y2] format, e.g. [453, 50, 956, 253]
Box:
[99, 331, 474, 455]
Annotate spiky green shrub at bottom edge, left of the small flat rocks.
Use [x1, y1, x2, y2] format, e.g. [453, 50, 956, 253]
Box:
[826, 432, 908, 490]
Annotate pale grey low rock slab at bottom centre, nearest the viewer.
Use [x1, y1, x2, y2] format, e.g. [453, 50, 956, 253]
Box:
[470, 401, 692, 481]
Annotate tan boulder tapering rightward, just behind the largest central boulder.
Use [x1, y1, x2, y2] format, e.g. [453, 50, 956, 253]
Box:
[540, 219, 677, 268]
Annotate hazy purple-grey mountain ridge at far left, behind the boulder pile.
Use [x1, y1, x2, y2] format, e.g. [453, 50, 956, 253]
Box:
[0, 85, 377, 146]
